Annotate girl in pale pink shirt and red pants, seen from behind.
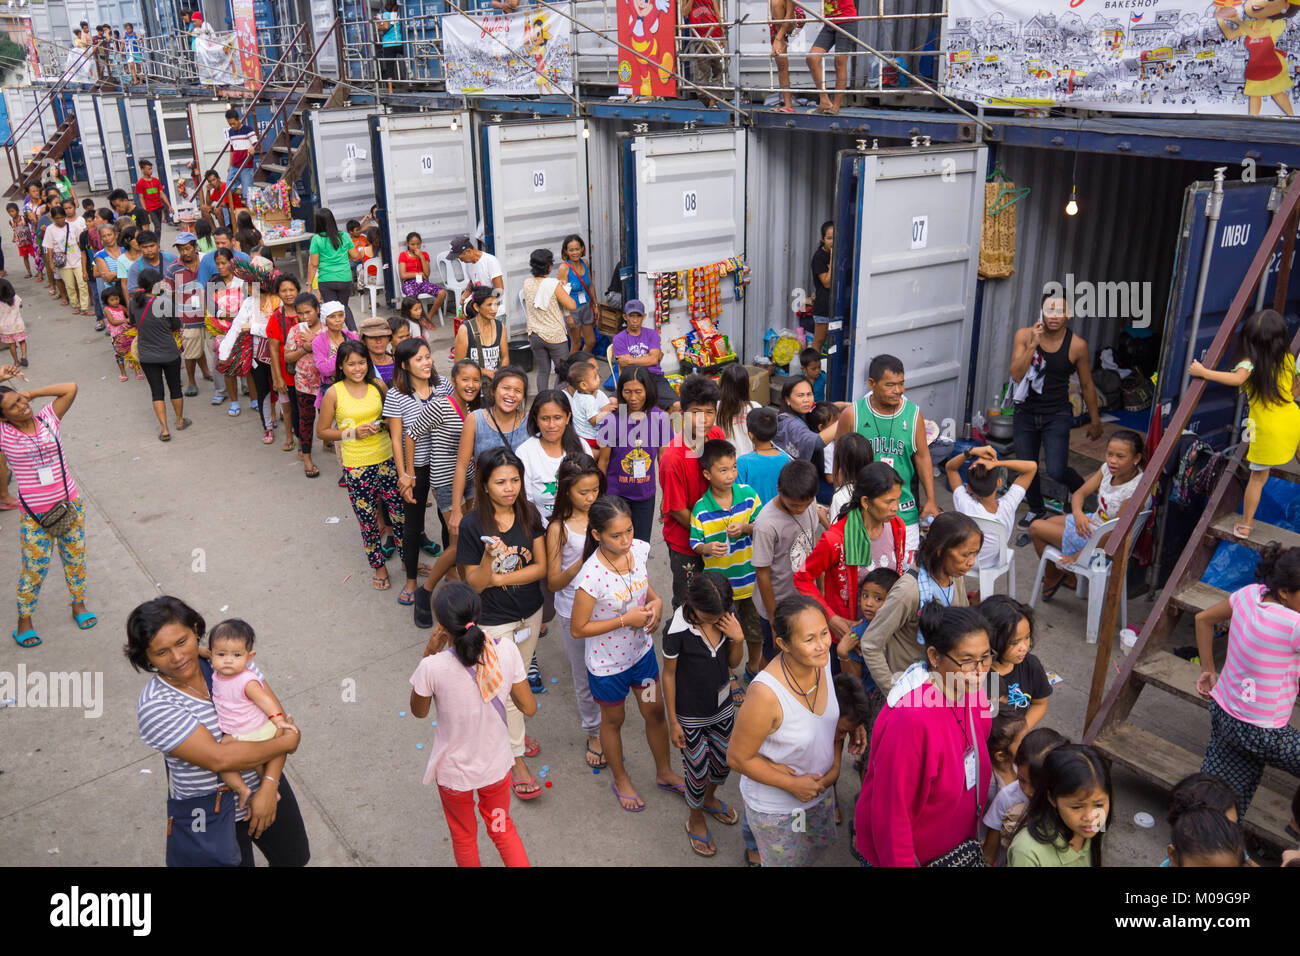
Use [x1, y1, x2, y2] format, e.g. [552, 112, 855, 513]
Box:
[411, 581, 537, 866]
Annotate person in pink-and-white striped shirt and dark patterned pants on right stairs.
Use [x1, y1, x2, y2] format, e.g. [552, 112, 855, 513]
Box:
[1196, 542, 1300, 817]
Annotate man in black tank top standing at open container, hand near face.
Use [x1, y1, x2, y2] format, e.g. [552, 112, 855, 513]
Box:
[1011, 294, 1101, 528]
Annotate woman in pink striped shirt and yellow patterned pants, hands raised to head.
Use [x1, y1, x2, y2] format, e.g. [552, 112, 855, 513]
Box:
[0, 377, 98, 648]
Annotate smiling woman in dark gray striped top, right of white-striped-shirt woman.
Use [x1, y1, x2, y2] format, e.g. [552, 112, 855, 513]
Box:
[403, 359, 482, 628]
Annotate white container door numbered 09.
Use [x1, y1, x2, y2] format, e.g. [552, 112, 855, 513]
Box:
[482, 120, 590, 332]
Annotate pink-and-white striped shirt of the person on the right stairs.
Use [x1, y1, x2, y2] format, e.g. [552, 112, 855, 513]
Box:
[1210, 584, 1300, 728]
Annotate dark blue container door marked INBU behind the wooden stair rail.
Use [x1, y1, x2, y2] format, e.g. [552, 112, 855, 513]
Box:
[1156, 179, 1300, 450]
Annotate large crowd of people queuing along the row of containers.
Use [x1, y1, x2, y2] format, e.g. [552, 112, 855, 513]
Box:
[0, 167, 1300, 866]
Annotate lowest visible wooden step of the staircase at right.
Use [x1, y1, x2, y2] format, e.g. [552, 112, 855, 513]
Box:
[1093, 723, 1296, 849]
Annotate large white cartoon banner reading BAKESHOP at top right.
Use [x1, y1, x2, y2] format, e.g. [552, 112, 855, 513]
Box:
[944, 0, 1300, 116]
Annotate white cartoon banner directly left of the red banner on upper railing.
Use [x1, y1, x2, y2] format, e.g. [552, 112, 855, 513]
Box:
[442, 10, 573, 96]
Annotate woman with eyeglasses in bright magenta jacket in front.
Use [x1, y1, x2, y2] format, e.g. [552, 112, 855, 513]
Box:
[854, 606, 993, 866]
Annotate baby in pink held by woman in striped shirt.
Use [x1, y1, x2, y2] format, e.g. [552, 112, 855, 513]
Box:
[208, 618, 298, 806]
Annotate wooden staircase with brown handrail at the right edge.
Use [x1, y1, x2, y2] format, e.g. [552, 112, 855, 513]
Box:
[1083, 174, 1300, 848]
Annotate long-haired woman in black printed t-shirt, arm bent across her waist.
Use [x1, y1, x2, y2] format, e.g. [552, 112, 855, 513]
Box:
[456, 446, 546, 800]
